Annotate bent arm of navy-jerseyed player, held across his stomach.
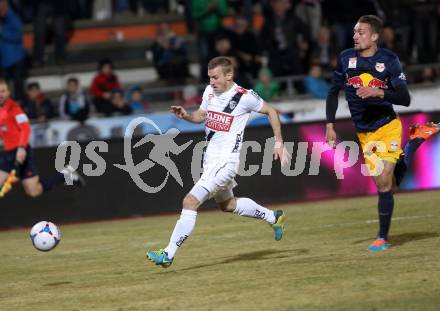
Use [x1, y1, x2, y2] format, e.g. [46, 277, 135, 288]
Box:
[356, 57, 411, 107]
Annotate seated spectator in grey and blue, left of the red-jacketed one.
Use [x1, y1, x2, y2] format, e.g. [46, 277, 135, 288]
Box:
[59, 78, 90, 122]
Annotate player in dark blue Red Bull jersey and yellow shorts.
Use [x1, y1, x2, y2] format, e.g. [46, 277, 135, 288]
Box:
[326, 15, 439, 252]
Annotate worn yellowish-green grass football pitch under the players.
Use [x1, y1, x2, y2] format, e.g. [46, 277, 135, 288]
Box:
[0, 191, 440, 311]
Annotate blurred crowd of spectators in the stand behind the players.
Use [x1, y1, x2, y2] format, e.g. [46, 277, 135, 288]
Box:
[0, 0, 440, 122]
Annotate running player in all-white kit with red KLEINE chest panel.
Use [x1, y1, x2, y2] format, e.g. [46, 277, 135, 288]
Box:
[147, 57, 289, 268]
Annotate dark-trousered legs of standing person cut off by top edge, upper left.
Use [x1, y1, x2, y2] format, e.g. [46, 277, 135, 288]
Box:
[32, 0, 69, 67]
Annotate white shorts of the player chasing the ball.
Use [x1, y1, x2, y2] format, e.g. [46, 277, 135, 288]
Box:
[190, 162, 239, 203]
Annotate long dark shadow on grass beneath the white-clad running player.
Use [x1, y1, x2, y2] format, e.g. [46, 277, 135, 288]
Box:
[161, 249, 310, 273]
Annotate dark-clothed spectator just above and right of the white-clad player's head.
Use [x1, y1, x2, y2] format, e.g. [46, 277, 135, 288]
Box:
[232, 16, 261, 77]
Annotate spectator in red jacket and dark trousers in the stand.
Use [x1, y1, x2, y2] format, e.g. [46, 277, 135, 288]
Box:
[90, 58, 121, 115]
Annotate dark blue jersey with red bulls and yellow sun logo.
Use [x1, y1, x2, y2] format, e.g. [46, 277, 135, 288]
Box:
[327, 48, 409, 132]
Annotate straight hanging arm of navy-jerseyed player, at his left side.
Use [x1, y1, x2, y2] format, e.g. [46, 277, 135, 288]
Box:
[325, 56, 345, 148]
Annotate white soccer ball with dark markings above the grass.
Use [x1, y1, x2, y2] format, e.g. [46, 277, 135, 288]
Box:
[30, 221, 61, 252]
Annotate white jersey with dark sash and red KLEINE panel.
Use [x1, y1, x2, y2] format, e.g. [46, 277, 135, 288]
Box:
[200, 83, 264, 163]
